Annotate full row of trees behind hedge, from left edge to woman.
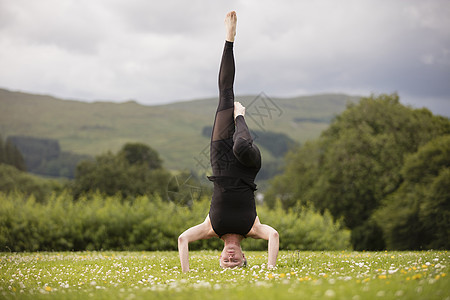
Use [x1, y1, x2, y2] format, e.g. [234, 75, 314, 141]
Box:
[0, 143, 206, 205]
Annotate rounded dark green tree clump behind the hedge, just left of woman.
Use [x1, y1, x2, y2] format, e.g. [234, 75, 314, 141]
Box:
[72, 143, 211, 206]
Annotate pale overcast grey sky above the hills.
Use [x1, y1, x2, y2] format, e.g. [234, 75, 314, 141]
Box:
[0, 0, 450, 116]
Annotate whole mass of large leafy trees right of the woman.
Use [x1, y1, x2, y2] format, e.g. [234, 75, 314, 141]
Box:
[265, 94, 450, 250]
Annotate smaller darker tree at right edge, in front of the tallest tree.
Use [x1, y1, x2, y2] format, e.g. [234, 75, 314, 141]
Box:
[373, 135, 450, 250]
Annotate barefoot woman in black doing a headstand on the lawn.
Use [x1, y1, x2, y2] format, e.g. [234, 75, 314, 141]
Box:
[178, 11, 279, 272]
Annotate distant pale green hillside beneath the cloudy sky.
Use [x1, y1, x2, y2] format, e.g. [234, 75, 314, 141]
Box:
[0, 89, 358, 171]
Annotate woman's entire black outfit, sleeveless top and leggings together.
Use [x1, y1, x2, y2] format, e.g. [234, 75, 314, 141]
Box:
[208, 42, 261, 237]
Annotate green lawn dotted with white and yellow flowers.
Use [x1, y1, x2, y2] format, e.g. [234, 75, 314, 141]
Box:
[0, 251, 450, 300]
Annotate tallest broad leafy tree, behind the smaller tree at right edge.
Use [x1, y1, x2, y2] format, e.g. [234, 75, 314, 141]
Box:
[266, 94, 450, 250]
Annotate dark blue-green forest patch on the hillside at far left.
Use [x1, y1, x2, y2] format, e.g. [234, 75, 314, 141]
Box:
[7, 136, 92, 179]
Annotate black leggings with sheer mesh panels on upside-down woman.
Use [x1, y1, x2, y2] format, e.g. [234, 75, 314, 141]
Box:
[210, 41, 261, 176]
